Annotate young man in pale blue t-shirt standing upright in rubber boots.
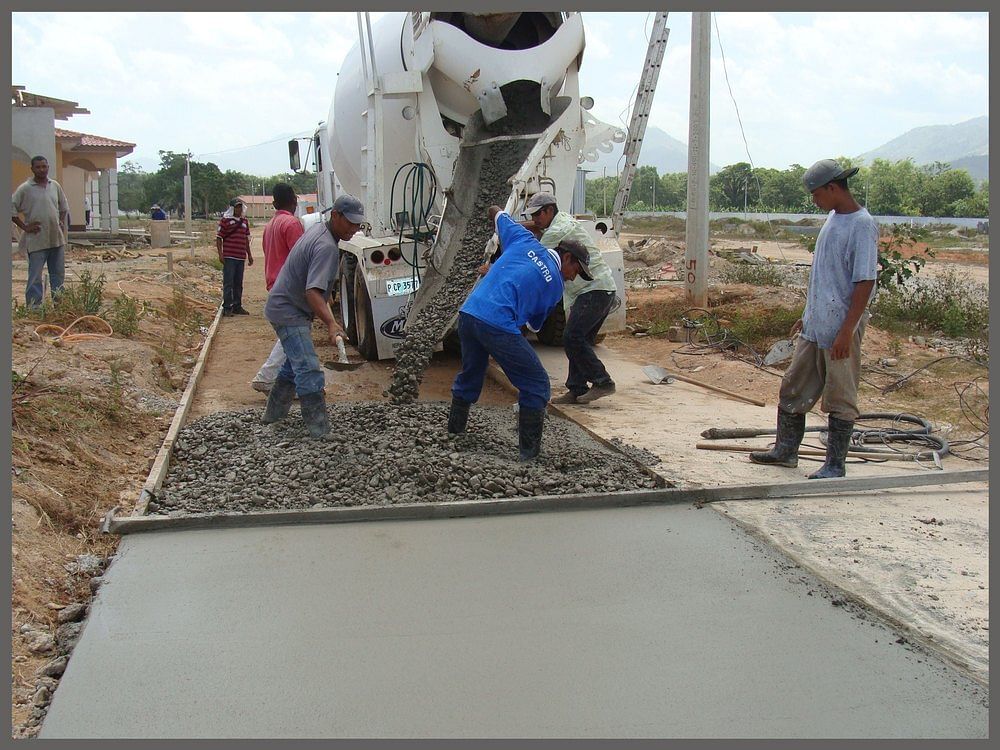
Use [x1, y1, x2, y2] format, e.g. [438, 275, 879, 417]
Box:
[750, 159, 878, 479]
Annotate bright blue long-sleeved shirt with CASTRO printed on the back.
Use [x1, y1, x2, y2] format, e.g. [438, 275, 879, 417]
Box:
[461, 212, 563, 333]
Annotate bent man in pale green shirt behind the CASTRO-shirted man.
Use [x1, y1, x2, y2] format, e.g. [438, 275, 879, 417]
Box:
[523, 193, 618, 404]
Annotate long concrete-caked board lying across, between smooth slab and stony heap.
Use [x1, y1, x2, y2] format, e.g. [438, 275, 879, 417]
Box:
[105, 469, 989, 534]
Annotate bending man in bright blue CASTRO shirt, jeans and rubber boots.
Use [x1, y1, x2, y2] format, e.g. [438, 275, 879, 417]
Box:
[448, 206, 592, 461]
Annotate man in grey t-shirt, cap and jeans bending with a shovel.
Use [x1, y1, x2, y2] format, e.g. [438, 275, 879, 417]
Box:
[261, 194, 365, 438]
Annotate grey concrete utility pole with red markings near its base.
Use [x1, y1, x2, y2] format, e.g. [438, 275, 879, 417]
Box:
[684, 12, 712, 307]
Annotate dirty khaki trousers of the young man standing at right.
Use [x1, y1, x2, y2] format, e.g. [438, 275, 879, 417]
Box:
[778, 322, 865, 422]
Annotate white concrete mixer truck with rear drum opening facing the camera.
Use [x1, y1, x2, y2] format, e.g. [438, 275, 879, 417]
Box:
[289, 12, 626, 360]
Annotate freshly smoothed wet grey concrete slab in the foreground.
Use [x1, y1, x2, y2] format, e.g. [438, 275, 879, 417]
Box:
[41, 506, 988, 738]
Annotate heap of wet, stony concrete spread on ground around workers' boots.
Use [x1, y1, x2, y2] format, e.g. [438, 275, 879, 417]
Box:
[149, 402, 654, 515]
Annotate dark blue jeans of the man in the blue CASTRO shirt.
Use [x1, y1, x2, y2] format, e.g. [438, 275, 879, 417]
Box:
[456, 313, 552, 409]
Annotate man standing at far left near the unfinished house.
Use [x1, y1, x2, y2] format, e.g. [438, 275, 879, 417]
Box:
[11, 156, 69, 306]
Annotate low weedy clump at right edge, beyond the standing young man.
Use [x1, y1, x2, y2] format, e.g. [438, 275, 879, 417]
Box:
[871, 268, 989, 341]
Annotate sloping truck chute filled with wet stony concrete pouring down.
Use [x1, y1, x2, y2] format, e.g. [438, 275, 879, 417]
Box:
[389, 112, 542, 403]
